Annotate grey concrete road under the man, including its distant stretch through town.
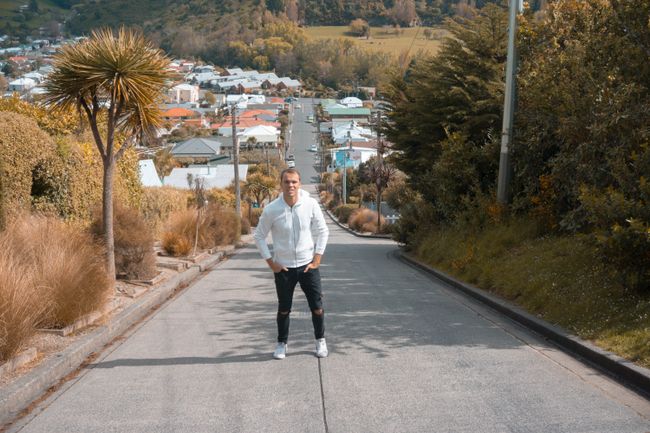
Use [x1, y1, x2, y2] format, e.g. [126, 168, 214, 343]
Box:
[12, 99, 650, 433]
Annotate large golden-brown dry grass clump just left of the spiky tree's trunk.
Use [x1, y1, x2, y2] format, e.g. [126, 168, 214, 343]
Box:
[6, 216, 111, 327]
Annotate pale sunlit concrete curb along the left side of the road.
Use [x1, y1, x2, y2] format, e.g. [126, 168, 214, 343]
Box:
[0, 243, 235, 430]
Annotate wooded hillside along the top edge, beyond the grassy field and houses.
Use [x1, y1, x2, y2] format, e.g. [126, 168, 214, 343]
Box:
[0, 0, 544, 43]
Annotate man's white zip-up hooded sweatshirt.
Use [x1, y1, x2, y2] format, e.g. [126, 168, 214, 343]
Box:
[253, 189, 329, 268]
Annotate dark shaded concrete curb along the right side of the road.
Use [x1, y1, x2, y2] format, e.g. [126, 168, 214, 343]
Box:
[395, 250, 650, 398]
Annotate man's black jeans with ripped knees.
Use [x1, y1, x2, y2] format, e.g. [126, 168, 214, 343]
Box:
[274, 265, 325, 343]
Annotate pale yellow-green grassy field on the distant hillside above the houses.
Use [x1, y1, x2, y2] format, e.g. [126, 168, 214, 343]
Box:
[305, 26, 448, 55]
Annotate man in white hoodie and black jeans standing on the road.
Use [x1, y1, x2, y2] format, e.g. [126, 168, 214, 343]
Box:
[254, 168, 329, 359]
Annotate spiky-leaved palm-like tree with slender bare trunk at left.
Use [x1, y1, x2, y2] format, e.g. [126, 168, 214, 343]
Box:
[46, 28, 169, 279]
